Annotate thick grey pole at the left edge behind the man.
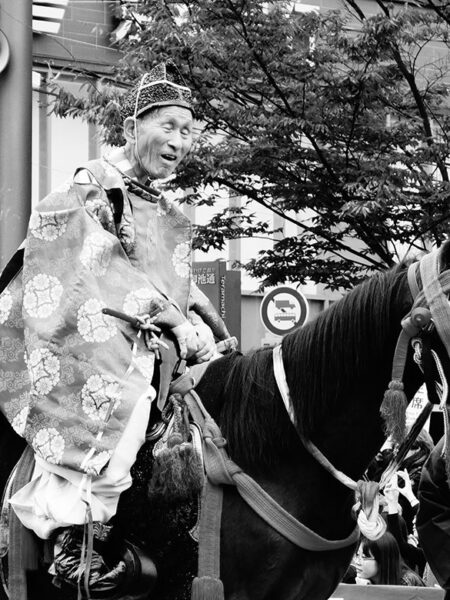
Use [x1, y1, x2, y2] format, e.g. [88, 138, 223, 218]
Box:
[0, 0, 33, 269]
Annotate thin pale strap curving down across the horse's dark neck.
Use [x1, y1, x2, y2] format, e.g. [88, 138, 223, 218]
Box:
[273, 344, 357, 490]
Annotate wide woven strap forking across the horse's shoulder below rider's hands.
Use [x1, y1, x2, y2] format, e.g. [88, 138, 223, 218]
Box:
[171, 364, 359, 600]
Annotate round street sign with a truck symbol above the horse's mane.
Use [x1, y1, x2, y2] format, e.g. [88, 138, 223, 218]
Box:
[260, 286, 308, 335]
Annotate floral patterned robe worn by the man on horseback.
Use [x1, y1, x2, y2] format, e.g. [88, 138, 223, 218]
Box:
[0, 159, 220, 475]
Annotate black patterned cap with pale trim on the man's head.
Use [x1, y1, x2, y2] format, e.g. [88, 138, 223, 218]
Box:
[120, 61, 194, 120]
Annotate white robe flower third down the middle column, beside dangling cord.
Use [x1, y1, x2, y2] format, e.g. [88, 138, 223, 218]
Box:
[81, 375, 120, 421]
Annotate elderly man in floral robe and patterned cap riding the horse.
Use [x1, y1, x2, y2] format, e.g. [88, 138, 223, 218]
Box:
[0, 63, 228, 587]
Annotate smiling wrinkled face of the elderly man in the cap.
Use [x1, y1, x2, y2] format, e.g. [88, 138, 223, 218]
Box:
[135, 106, 193, 179]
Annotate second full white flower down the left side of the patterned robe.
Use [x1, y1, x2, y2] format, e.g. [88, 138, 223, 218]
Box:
[23, 273, 63, 319]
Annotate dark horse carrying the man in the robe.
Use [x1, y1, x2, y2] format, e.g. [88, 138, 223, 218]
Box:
[0, 245, 446, 600]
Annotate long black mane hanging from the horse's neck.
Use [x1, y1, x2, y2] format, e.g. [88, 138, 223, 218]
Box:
[220, 264, 411, 464]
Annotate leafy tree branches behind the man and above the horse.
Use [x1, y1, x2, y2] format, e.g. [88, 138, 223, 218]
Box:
[47, 0, 450, 288]
